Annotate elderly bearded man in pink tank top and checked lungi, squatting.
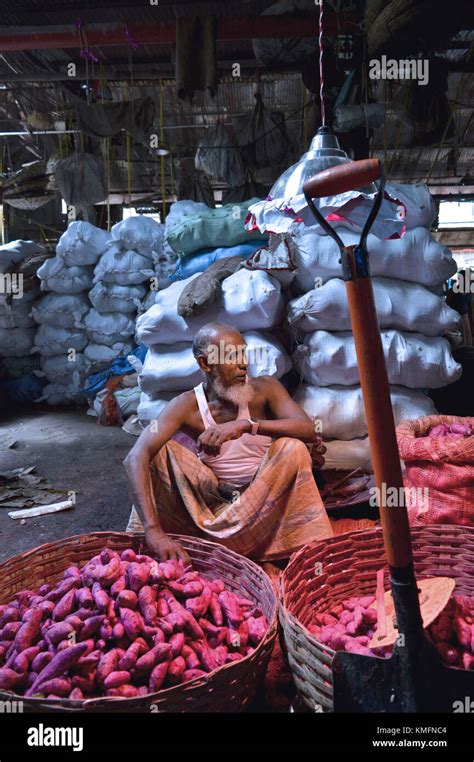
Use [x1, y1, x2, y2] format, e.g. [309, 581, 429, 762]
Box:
[124, 323, 333, 561]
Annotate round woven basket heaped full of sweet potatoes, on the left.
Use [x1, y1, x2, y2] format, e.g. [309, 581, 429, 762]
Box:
[0, 532, 277, 712]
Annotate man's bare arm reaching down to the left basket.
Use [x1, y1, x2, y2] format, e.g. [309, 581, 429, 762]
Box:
[123, 395, 190, 563]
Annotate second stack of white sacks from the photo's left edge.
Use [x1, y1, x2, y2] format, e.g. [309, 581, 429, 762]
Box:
[33, 221, 106, 405]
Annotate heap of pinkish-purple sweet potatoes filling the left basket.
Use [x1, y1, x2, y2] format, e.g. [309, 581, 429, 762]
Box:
[0, 548, 268, 699]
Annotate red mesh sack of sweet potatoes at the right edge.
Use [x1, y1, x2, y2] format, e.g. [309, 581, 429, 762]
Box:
[397, 415, 474, 526]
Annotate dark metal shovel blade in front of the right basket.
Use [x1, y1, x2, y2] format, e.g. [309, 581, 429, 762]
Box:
[333, 641, 474, 713]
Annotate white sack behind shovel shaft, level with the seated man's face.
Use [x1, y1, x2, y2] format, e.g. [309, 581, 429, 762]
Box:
[293, 331, 462, 389]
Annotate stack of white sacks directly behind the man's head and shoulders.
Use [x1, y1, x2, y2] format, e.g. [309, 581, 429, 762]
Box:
[133, 269, 291, 423]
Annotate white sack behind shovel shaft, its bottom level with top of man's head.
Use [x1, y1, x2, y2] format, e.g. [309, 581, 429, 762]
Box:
[288, 278, 460, 336]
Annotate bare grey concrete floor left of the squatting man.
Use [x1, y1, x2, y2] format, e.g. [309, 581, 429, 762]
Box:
[0, 408, 136, 561]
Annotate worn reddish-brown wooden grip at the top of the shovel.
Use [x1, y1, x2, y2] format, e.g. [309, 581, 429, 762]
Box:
[303, 159, 382, 198]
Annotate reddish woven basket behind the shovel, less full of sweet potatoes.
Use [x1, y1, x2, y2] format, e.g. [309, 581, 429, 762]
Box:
[279, 524, 474, 711]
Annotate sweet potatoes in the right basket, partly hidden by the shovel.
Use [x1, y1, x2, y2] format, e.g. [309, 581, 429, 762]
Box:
[308, 595, 474, 670]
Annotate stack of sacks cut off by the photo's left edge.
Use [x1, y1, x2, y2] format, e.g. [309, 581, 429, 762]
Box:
[0, 240, 47, 379]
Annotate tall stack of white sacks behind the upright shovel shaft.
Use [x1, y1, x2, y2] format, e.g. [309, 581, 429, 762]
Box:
[284, 184, 461, 469]
